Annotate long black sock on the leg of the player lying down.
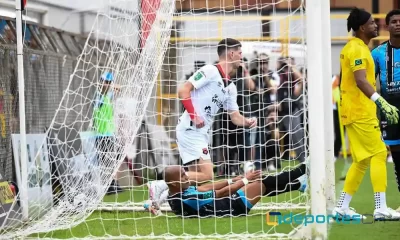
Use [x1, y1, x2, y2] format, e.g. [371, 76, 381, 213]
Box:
[262, 164, 306, 196]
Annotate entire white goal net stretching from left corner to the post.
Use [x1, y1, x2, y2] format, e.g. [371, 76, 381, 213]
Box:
[2, 0, 332, 239]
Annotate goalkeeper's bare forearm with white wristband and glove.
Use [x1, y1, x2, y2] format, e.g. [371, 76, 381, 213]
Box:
[354, 69, 399, 124]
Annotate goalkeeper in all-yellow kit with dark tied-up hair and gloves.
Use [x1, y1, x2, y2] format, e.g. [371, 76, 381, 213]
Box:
[333, 8, 400, 220]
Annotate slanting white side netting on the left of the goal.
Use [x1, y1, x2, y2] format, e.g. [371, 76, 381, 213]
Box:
[2, 0, 174, 239]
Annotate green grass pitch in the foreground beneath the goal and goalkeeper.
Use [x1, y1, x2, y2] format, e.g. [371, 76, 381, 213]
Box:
[28, 160, 400, 240]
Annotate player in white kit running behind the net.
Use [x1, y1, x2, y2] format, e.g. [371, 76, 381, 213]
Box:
[144, 38, 257, 213]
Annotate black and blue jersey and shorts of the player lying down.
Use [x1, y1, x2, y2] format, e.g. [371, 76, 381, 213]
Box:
[168, 186, 252, 217]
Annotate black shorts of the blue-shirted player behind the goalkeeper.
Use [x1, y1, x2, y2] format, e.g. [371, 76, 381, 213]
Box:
[380, 98, 400, 146]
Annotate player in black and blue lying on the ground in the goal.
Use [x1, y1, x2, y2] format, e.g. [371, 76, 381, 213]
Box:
[165, 164, 307, 217]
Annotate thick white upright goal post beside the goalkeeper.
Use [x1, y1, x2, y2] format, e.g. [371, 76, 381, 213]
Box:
[306, 0, 335, 239]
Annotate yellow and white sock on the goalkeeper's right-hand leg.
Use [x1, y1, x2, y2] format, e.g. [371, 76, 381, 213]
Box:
[370, 151, 387, 209]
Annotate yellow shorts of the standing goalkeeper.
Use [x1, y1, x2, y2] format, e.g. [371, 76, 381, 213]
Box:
[346, 119, 386, 162]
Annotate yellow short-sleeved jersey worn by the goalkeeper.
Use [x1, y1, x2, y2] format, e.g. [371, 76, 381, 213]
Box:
[340, 38, 377, 125]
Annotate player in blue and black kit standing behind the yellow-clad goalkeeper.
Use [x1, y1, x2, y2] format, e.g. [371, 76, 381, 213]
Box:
[372, 9, 400, 212]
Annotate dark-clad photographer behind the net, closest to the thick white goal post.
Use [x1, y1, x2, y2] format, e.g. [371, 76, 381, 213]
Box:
[277, 55, 305, 162]
